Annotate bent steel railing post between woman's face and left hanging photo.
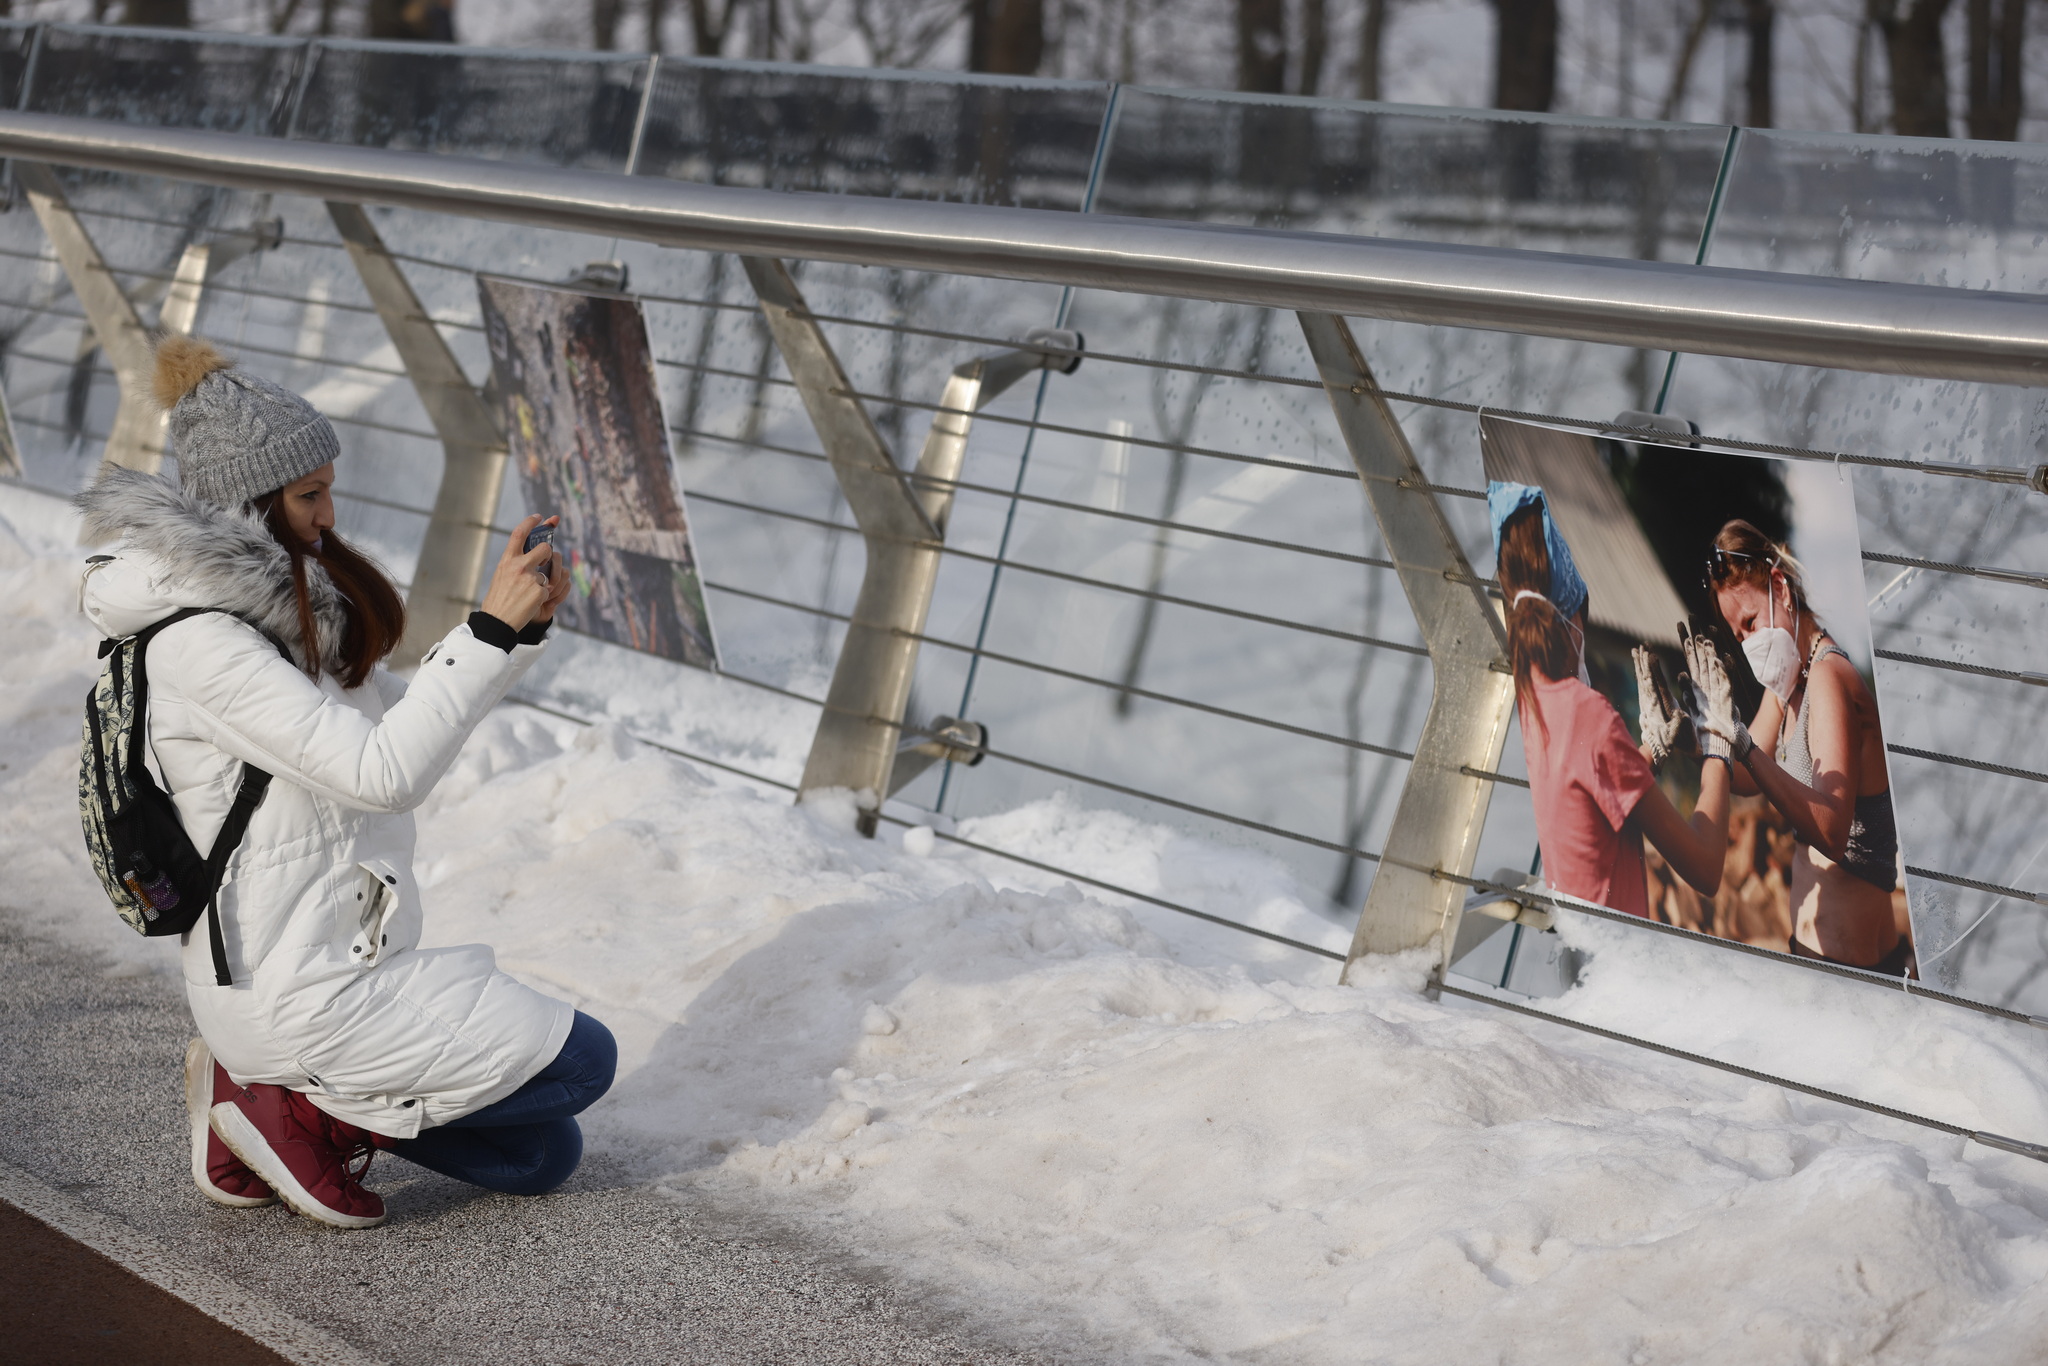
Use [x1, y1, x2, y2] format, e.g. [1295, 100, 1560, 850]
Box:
[328, 203, 506, 664]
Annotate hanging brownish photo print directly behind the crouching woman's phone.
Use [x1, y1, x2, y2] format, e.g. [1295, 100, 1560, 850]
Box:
[477, 274, 719, 670]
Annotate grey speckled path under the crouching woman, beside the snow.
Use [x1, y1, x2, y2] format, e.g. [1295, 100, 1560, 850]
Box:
[0, 905, 1051, 1366]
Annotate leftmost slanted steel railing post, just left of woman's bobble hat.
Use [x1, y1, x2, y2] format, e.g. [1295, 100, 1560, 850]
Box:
[14, 162, 160, 473]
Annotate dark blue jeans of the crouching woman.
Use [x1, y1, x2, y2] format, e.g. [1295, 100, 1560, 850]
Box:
[391, 1010, 618, 1196]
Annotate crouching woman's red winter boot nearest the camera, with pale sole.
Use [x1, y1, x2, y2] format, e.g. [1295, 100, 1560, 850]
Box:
[213, 1085, 385, 1229]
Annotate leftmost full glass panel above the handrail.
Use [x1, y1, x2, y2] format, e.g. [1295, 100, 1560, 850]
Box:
[29, 25, 305, 133]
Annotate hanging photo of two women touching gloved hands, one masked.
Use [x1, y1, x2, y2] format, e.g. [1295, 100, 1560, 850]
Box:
[1481, 418, 1915, 977]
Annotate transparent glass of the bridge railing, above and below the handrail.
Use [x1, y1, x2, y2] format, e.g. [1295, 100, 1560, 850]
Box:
[0, 23, 2048, 1014]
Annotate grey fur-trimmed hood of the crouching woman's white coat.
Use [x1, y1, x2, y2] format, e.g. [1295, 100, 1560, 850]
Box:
[74, 465, 348, 672]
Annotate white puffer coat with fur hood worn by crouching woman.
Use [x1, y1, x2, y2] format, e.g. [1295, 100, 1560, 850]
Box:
[78, 469, 575, 1139]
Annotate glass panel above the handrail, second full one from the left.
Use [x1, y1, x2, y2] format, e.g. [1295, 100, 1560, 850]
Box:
[297, 41, 647, 170]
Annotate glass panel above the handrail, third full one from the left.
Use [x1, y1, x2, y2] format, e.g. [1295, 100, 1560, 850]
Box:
[639, 61, 1110, 209]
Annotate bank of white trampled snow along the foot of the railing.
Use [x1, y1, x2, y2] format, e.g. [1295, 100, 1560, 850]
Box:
[12, 492, 2048, 1362]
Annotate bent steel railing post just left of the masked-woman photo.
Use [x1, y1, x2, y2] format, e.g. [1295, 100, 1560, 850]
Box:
[1298, 313, 1513, 977]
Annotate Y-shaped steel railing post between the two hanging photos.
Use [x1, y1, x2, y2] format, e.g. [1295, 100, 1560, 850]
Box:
[741, 256, 1081, 836]
